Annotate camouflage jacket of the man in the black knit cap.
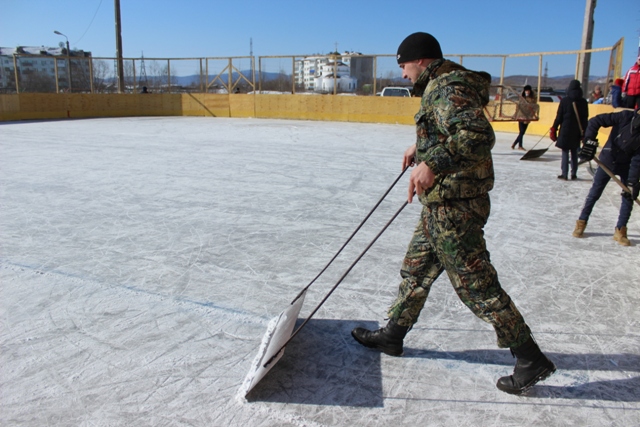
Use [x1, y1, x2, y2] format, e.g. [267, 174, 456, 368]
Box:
[414, 59, 495, 204]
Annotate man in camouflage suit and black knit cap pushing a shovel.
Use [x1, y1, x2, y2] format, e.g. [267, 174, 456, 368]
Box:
[352, 33, 556, 394]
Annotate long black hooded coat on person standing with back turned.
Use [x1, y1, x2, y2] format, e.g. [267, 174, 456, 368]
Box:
[552, 80, 589, 150]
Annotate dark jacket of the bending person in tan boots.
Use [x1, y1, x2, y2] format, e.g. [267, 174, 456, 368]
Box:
[585, 110, 640, 175]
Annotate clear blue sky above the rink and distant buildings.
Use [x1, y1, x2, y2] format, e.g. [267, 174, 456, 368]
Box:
[0, 0, 640, 76]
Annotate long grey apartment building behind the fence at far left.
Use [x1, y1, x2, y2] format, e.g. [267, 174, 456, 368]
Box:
[0, 46, 91, 92]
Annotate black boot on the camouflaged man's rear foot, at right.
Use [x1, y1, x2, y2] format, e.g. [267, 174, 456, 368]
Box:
[496, 337, 556, 394]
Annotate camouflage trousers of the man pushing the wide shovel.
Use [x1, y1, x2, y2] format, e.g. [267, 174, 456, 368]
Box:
[388, 196, 531, 348]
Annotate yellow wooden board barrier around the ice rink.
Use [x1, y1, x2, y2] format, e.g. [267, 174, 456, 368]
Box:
[0, 93, 614, 141]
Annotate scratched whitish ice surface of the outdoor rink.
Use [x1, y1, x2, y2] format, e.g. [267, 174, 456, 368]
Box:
[0, 117, 640, 427]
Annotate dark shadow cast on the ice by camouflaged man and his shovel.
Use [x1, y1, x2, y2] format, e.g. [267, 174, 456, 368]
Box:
[246, 319, 640, 408]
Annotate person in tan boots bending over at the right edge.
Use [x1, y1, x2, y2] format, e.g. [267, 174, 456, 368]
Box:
[573, 109, 640, 246]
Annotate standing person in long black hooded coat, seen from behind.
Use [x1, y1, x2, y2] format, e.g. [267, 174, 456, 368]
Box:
[549, 80, 589, 181]
